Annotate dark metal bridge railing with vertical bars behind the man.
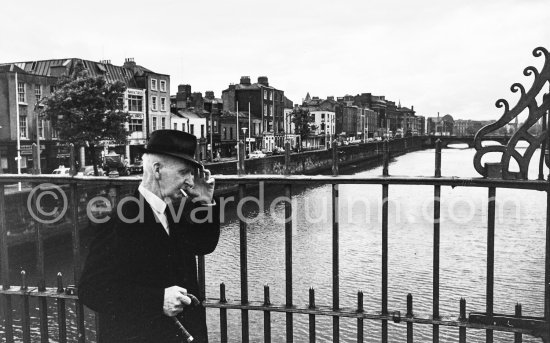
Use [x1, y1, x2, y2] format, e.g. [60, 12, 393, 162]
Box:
[0, 141, 550, 343]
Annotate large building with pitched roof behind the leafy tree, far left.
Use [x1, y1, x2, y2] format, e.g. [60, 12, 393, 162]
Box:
[0, 58, 170, 173]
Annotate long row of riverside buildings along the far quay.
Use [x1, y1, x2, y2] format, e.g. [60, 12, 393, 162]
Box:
[0, 58, 425, 173]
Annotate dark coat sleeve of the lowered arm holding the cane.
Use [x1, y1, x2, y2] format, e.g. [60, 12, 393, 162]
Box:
[78, 223, 164, 319]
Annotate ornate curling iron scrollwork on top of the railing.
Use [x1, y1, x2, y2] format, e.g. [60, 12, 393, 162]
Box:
[474, 47, 550, 180]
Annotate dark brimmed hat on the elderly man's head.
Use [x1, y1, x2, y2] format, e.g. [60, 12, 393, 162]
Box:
[143, 130, 200, 167]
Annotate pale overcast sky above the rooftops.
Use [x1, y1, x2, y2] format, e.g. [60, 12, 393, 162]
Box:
[0, 0, 550, 119]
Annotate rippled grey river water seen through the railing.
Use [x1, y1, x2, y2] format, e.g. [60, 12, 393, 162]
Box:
[2, 149, 548, 342]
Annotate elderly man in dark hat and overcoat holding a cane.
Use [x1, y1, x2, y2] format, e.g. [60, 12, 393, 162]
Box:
[78, 130, 220, 343]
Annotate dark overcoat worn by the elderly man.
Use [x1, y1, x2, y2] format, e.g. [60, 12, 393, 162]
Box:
[78, 192, 220, 343]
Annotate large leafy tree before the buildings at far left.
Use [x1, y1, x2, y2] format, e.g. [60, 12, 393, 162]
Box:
[42, 76, 130, 175]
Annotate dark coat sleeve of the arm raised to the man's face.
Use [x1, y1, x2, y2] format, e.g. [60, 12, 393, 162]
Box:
[176, 198, 220, 255]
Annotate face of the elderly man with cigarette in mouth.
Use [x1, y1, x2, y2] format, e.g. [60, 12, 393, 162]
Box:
[159, 159, 196, 200]
